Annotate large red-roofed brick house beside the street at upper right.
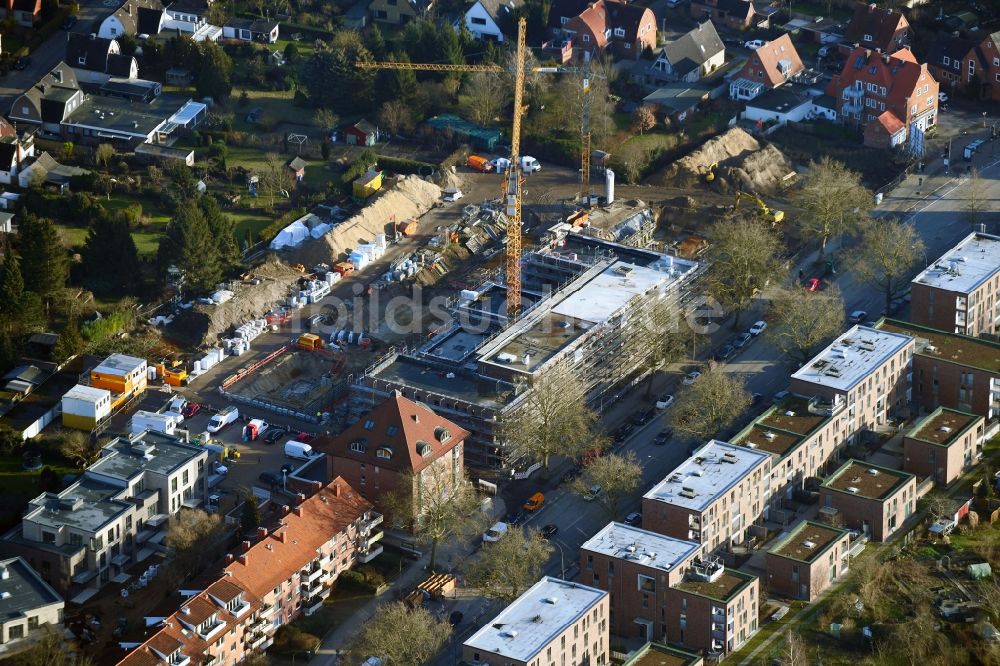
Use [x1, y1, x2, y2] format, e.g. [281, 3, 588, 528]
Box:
[826, 47, 938, 148]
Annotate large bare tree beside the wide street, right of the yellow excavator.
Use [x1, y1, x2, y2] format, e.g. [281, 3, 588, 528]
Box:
[796, 157, 875, 261]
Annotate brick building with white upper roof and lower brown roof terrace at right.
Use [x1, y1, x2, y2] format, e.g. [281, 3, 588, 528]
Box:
[580, 523, 759, 654]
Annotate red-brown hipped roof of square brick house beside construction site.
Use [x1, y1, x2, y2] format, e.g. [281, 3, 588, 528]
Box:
[312, 395, 469, 474]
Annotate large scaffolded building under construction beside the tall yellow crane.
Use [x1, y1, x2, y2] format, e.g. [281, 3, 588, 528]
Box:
[350, 228, 699, 469]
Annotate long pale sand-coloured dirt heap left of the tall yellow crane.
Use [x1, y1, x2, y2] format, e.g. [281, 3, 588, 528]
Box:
[286, 176, 441, 266]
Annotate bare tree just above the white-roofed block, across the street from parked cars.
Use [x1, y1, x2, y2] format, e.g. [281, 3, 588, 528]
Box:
[764, 285, 844, 363]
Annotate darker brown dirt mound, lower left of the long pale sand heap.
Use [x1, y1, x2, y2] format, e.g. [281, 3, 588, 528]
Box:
[164, 261, 301, 348]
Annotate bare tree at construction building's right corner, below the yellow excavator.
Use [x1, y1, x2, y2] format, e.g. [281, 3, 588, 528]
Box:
[706, 215, 785, 329]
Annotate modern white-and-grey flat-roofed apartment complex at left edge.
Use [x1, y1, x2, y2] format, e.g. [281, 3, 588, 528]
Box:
[0, 431, 208, 603]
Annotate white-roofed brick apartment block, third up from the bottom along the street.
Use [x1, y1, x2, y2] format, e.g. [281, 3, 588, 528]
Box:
[642, 440, 771, 557]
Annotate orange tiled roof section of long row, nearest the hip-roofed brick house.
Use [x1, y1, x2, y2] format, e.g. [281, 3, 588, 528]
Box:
[226, 477, 372, 597]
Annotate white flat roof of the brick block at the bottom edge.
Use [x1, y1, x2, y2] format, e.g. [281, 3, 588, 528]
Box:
[465, 576, 608, 661]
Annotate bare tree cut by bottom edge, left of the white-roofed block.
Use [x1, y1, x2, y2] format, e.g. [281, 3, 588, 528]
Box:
[344, 601, 451, 666]
